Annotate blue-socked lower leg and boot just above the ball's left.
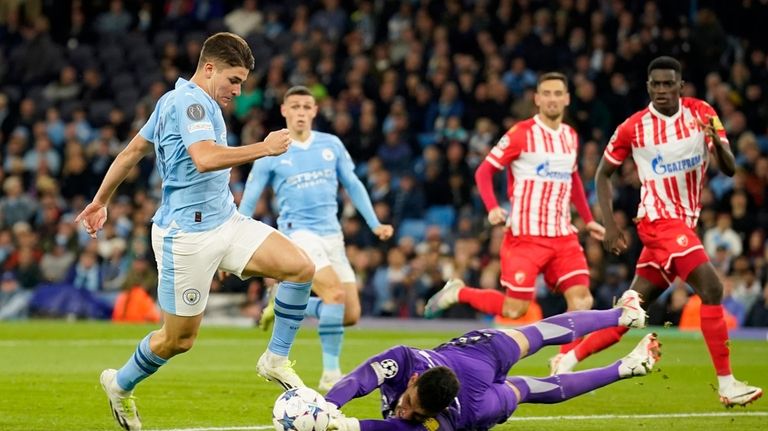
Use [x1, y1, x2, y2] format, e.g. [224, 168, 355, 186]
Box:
[257, 281, 312, 389]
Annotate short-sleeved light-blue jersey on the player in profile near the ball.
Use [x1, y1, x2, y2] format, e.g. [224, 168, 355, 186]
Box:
[139, 78, 236, 232]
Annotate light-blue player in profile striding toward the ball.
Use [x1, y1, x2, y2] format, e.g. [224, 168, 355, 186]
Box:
[77, 33, 315, 431]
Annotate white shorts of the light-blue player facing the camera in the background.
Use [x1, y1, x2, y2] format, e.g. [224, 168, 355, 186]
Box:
[290, 230, 355, 283]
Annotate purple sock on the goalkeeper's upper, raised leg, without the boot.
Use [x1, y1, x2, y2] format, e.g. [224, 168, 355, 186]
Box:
[518, 308, 621, 356]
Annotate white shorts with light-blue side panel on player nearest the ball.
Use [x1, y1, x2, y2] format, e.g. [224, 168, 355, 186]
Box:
[152, 213, 277, 316]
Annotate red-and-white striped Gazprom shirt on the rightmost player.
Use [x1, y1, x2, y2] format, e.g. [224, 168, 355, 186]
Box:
[604, 97, 728, 228]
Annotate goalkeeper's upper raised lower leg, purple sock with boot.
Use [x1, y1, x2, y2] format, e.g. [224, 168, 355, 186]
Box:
[517, 290, 645, 356]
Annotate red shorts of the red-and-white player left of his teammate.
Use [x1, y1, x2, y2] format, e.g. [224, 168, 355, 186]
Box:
[501, 231, 589, 300]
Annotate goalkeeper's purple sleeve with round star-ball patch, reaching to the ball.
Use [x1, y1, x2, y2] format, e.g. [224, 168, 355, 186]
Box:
[325, 346, 410, 408]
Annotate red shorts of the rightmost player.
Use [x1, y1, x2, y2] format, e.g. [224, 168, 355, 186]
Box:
[635, 219, 709, 287]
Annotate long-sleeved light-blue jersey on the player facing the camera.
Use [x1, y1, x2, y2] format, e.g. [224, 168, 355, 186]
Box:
[239, 131, 380, 235]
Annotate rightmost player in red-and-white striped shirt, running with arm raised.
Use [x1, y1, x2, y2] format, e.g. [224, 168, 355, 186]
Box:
[558, 57, 762, 406]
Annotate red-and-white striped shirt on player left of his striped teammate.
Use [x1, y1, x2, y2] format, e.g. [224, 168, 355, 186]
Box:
[485, 115, 579, 237]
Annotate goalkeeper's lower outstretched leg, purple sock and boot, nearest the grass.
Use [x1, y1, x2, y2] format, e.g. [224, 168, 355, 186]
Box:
[507, 334, 661, 404]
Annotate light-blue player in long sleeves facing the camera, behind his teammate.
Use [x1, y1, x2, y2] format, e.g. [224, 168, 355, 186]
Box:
[239, 86, 392, 391]
